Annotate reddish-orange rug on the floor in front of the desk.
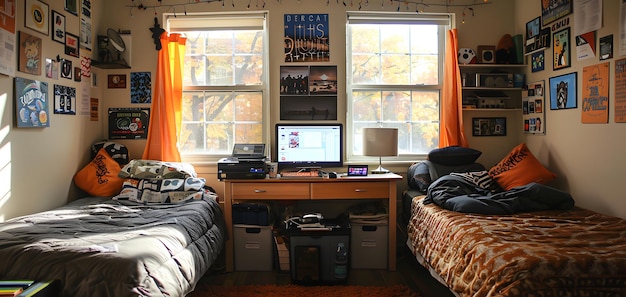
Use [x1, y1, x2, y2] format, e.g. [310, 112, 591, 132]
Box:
[188, 285, 418, 297]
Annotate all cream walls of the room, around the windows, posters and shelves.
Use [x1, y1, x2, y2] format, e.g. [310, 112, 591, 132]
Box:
[11, 0, 626, 221]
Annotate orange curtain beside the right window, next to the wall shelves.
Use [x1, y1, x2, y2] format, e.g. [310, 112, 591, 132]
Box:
[439, 29, 468, 147]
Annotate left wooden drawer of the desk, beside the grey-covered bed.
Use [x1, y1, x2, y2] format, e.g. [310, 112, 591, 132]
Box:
[231, 183, 310, 200]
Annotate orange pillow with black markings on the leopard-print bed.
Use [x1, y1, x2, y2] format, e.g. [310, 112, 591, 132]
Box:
[489, 143, 556, 190]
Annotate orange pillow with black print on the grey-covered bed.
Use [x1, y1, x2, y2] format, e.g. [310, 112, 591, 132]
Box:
[74, 148, 124, 196]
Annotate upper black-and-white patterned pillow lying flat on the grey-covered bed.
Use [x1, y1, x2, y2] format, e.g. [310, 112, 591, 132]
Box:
[119, 160, 197, 179]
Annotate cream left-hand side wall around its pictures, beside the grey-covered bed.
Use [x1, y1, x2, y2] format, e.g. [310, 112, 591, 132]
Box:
[0, 0, 102, 222]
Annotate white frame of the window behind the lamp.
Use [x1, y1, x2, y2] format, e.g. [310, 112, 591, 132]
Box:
[345, 11, 455, 163]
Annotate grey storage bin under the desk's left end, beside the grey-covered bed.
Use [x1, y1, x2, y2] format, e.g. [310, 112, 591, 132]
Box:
[233, 224, 274, 271]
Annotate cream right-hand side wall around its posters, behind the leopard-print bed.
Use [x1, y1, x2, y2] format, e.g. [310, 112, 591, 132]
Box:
[515, 0, 626, 218]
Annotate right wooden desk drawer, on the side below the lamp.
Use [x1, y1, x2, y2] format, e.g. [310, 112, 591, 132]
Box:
[311, 182, 389, 199]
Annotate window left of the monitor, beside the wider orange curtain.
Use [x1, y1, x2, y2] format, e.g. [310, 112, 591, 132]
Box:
[166, 12, 269, 157]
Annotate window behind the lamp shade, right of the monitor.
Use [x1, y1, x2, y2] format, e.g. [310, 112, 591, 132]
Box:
[346, 12, 451, 160]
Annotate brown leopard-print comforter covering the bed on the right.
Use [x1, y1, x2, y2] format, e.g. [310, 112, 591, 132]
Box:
[407, 196, 626, 297]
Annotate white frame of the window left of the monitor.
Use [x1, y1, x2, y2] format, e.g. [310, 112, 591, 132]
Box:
[163, 11, 270, 163]
